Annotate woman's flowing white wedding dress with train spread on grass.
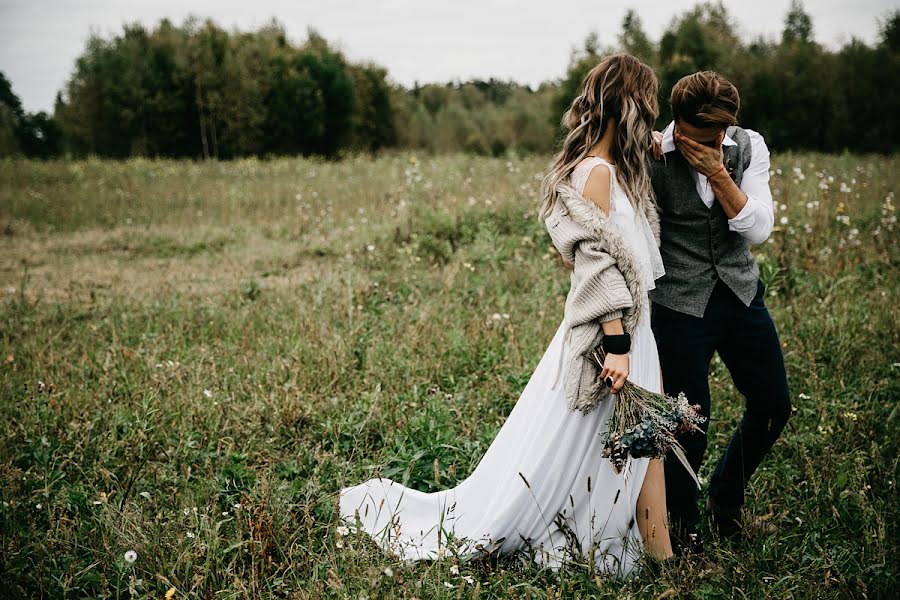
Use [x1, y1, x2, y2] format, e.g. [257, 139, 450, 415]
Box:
[340, 157, 662, 576]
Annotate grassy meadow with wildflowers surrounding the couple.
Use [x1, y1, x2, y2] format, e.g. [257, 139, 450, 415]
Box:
[0, 154, 900, 599]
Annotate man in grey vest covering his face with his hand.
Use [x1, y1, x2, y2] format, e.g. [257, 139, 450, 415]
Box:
[650, 71, 791, 553]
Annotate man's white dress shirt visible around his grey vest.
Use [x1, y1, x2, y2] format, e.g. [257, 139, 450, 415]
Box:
[662, 121, 775, 244]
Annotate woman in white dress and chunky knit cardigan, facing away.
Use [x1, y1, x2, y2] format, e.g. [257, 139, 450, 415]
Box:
[339, 54, 672, 576]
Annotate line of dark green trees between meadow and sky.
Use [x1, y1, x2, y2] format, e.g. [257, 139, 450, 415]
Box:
[0, 0, 900, 159]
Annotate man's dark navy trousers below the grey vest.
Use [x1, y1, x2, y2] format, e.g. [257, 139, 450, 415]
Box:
[651, 280, 791, 538]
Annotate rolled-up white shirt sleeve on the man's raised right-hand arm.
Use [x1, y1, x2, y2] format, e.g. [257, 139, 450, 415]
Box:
[728, 129, 775, 244]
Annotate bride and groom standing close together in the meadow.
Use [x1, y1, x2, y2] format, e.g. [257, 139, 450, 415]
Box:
[339, 54, 791, 576]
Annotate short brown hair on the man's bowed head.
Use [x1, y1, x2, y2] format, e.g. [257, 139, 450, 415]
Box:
[669, 71, 741, 129]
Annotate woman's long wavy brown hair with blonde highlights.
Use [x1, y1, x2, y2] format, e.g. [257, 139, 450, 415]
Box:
[538, 53, 659, 222]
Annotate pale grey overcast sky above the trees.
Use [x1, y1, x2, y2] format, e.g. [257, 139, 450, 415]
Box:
[0, 0, 900, 112]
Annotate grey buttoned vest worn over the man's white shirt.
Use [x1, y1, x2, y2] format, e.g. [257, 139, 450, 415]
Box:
[650, 127, 759, 317]
